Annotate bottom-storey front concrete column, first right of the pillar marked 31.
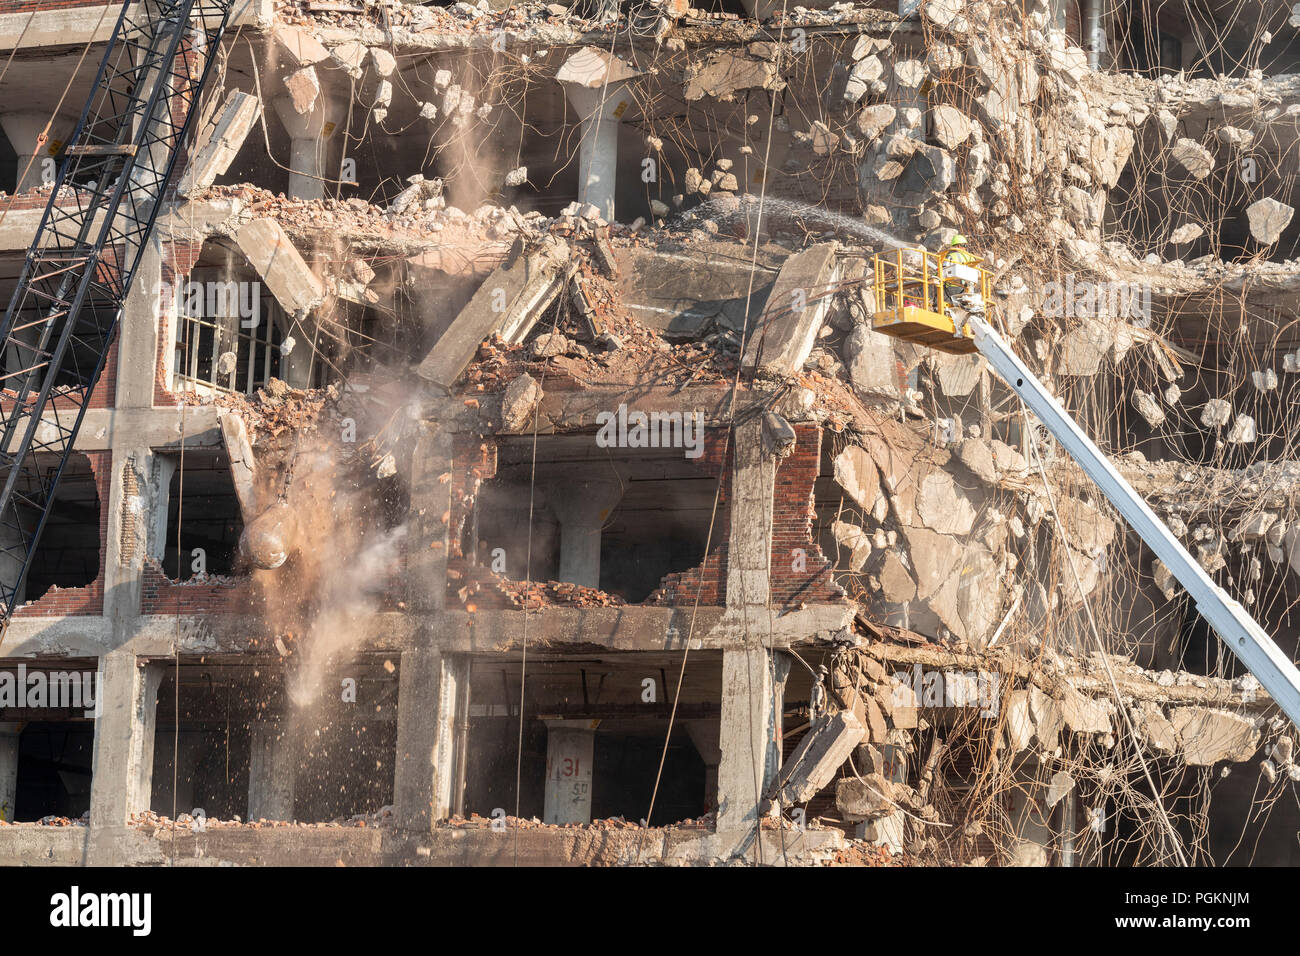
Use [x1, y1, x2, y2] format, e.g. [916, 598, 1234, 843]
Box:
[716, 648, 789, 832]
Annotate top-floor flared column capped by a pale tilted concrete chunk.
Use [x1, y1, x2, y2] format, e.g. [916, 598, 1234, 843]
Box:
[555, 47, 638, 222]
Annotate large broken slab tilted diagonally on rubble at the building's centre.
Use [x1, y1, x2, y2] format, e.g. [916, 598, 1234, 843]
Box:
[416, 242, 569, 389]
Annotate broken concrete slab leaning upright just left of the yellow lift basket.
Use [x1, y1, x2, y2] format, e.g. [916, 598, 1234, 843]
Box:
[742, 242, 840, 377]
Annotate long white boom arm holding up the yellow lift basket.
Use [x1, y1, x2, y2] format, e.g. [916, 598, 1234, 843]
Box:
[967, 316, 1300, 727]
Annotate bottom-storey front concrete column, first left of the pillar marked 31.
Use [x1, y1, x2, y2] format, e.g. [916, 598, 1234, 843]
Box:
[394, 635, 469, 830]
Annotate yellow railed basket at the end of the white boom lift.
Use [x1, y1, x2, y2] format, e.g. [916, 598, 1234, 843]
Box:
[871, 248, 991, 355]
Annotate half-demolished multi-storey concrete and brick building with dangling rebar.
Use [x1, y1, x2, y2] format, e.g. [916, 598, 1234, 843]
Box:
[0, 0, 1300, 865]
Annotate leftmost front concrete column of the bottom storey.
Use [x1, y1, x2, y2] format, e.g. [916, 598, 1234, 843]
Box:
[90, 650, 163, 864]
